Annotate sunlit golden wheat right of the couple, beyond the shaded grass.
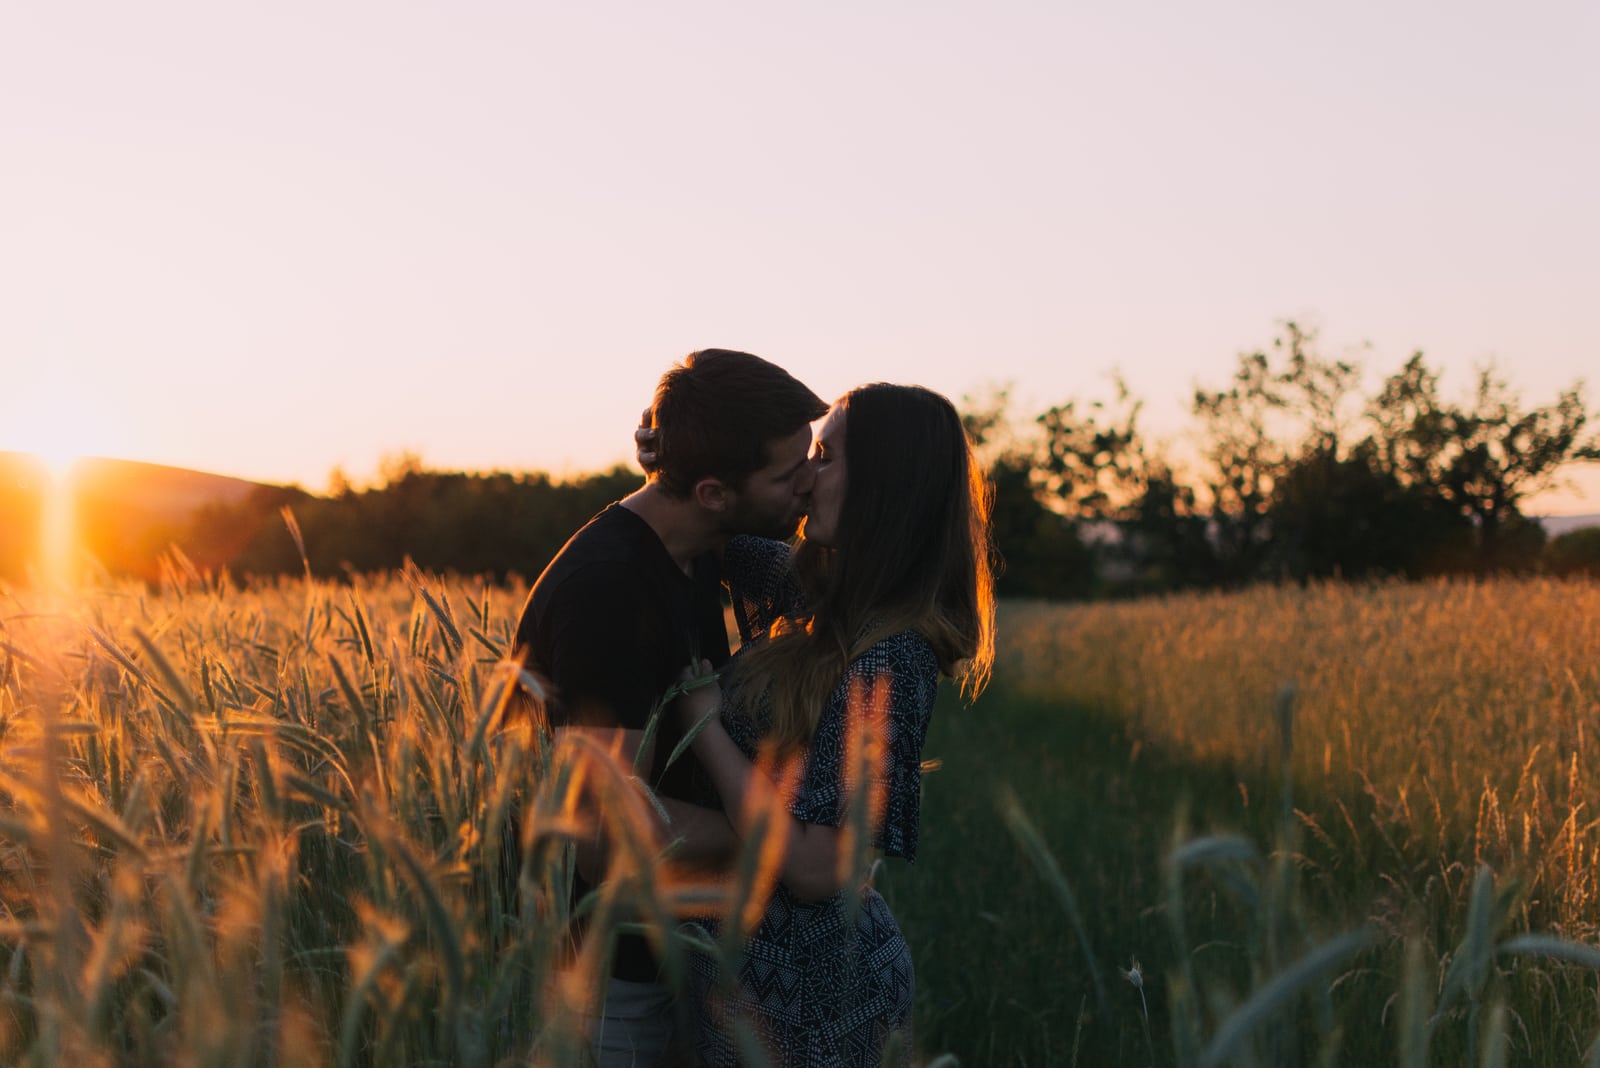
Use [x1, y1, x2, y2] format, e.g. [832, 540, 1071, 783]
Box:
[997, 582, 1600, 942]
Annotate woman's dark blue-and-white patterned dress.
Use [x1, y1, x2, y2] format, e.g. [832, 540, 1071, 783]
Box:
[691, 537, 939, 1068]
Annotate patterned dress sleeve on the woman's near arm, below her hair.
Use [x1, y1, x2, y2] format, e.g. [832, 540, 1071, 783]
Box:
[789, 632, 939, 860]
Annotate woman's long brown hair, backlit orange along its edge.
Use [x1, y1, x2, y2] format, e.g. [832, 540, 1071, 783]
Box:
[734, 384, 995, 751]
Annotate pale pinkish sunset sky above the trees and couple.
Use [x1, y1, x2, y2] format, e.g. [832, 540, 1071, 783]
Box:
[0, 0, 1600, 512]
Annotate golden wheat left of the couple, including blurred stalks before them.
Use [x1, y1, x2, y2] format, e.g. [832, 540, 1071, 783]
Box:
[0, 562, 915, 1068]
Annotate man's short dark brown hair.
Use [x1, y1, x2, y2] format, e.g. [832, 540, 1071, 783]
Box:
[650, 349, 827, 497]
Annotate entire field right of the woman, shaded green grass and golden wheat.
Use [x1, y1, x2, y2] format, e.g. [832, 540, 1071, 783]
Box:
[890, 582, 1600, 1065]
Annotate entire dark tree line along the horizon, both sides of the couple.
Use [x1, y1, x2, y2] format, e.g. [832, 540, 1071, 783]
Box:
[0, 323, 1600, 598]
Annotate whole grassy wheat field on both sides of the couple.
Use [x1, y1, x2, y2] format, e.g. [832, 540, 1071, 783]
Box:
[0, 560, 1600, 1065]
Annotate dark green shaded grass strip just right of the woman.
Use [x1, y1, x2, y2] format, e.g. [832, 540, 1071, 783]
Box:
[885, 694, 1272, 1065]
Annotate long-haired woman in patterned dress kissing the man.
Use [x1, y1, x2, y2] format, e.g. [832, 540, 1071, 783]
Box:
[677, 385, 994, 1068]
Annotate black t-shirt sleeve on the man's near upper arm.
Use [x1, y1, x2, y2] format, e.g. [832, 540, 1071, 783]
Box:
[534, 564, 670, 731]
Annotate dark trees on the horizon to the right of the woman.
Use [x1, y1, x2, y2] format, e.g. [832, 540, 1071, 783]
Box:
[966, 321, 1600, 596]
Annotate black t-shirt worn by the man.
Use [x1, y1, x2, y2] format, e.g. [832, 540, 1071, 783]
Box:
[517, 504, 728, 982]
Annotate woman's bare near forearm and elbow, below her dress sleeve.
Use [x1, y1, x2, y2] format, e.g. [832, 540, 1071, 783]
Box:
[680, 668, 845, 902]
